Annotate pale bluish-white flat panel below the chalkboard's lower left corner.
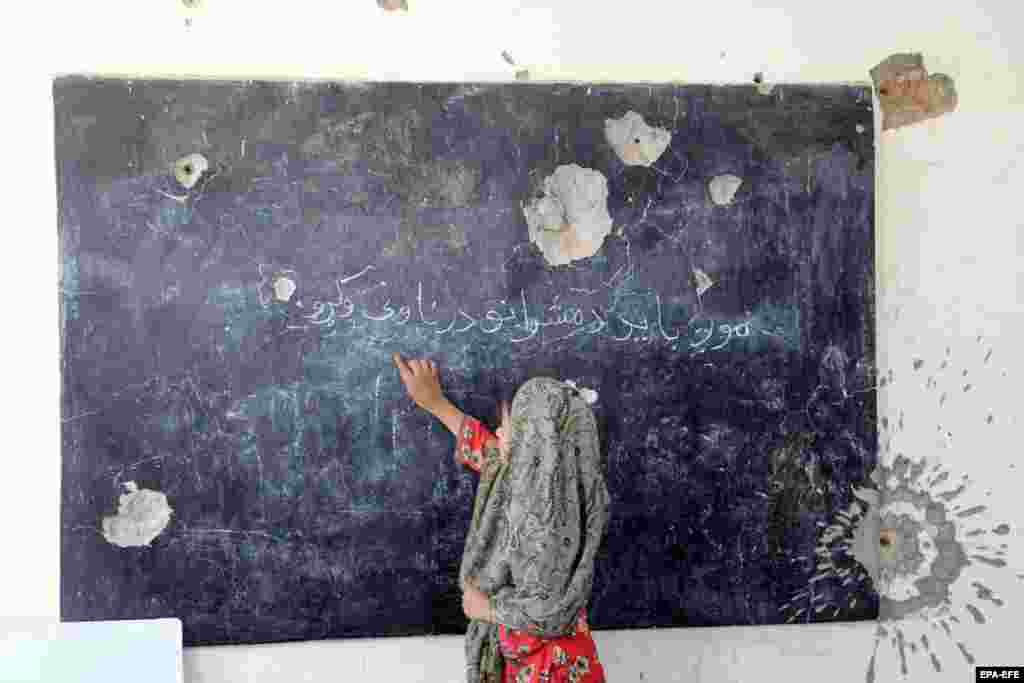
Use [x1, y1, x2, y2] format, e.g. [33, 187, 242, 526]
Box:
[0, 618, 182, 683]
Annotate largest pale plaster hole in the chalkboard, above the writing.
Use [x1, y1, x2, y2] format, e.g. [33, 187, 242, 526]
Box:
[522, 164, 611, 265]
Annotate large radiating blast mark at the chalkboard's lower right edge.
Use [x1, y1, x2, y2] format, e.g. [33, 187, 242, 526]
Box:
[781, 339, 1013, 683]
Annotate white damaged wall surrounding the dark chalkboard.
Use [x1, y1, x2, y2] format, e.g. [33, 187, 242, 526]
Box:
[0, 0, 1024, 683]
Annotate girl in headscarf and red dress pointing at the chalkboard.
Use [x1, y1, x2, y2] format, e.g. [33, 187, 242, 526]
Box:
[394, 353, 608, 683]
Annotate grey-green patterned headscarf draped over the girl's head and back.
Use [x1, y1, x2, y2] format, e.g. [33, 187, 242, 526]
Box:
[460, 378, 609, 683]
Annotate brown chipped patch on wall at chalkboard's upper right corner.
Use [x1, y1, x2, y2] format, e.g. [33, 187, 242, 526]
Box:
[871, 53, 956, 130]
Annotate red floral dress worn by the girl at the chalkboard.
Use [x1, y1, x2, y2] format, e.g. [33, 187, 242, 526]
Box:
[455, 418, 606, 683]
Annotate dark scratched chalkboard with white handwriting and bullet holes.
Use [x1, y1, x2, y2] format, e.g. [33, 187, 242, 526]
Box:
[54, 77, 878, 645]
